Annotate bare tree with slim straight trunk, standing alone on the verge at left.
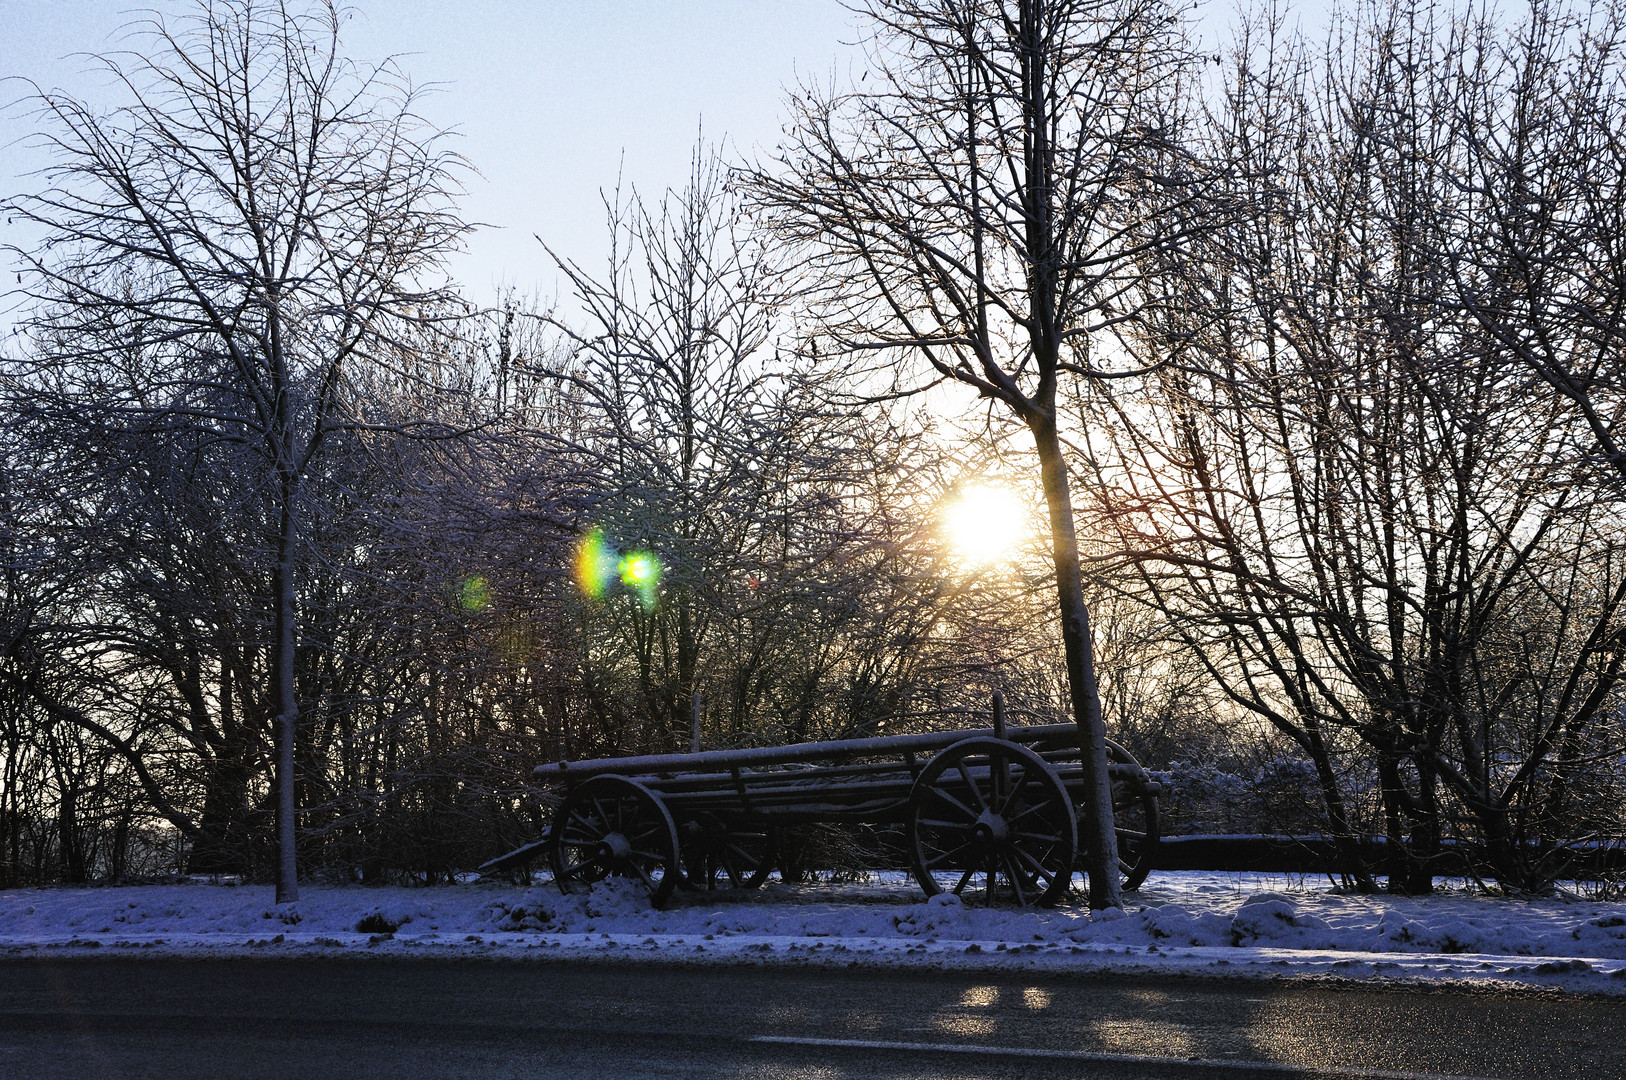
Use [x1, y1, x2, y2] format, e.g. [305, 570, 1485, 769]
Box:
[7, 0, 465, 901]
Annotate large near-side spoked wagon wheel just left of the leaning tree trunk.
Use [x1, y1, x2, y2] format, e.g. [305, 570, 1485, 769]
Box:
[909, 738, 1078, 908]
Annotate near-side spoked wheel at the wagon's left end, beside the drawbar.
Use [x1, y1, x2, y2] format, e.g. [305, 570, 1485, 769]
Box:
[548, 774, 683, 908]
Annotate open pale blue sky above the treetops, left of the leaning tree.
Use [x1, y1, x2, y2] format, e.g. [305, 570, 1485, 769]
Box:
[0, 0, 857, 312]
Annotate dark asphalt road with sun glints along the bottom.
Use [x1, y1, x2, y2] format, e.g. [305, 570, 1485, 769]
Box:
[0, 958, 1626, 1080]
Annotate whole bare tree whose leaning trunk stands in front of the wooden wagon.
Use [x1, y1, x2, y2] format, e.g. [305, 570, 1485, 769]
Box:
[750, 0, 1197, 908]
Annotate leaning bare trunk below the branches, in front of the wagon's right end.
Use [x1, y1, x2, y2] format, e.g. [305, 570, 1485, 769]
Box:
[1029, 415, 1124, 908]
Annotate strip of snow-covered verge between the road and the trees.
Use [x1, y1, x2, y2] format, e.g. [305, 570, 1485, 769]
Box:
[0, 872, 1626, 995]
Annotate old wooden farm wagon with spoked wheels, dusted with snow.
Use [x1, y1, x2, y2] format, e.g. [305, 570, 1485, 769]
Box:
[513, 696, 1159, 908]
